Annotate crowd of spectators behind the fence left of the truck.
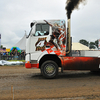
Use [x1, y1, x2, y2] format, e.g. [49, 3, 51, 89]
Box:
[0, 49, 25, 60]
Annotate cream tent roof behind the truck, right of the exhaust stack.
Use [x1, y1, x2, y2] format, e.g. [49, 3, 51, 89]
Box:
[72, 43, 90, 50]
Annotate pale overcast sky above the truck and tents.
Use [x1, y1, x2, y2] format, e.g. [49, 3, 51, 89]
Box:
[0, 0, 100, 48]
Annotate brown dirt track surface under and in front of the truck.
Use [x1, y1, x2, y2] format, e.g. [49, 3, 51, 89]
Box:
[0, 66, 100, 100]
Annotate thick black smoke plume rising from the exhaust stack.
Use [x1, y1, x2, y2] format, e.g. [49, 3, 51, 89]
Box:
[65, 0, 86, 19]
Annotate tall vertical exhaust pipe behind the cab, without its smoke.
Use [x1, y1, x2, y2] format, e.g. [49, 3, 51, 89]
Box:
[66, 18, 72, 56]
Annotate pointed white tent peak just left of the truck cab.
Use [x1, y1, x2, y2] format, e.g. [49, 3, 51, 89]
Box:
[13, 33, 26, 50]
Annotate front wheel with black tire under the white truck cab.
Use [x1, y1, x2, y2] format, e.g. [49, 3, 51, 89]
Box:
[41, 60, 58, 79]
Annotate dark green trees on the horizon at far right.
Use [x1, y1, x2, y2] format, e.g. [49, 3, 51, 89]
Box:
[79, 39, 99, 49]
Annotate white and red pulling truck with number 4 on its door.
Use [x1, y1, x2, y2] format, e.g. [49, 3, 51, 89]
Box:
[25, 19, 100, 78]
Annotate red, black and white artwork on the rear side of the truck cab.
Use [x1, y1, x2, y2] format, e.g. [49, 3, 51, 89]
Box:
[42, 20, 66, 56]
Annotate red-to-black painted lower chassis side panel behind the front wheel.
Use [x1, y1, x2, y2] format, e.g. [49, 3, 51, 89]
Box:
[62, 57, 100, 71]
